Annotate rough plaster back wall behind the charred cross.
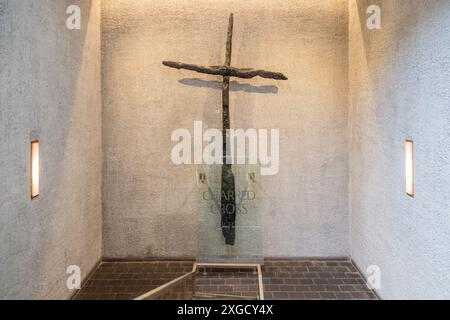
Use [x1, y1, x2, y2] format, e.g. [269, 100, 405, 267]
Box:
[102, 0, 349, 258]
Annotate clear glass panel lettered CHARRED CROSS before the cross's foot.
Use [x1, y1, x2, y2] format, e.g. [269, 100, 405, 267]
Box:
[197, 165, 263, 263]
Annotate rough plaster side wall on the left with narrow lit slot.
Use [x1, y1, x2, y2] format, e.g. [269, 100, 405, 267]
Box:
[0, 0, 101, 299]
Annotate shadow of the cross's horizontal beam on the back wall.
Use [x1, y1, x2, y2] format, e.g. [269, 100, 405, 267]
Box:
[178, 78, 278, 94]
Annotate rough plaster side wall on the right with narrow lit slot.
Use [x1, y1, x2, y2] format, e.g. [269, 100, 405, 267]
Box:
[349, 0, 450, 299]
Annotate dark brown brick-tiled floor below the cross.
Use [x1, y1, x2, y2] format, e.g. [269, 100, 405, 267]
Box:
[74, 260, 377, 300]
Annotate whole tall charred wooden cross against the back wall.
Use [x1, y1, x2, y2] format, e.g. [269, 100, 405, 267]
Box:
[163, 14, 287, 246]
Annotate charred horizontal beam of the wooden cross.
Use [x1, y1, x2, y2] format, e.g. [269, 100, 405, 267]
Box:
[163, 61, 288, 80]
